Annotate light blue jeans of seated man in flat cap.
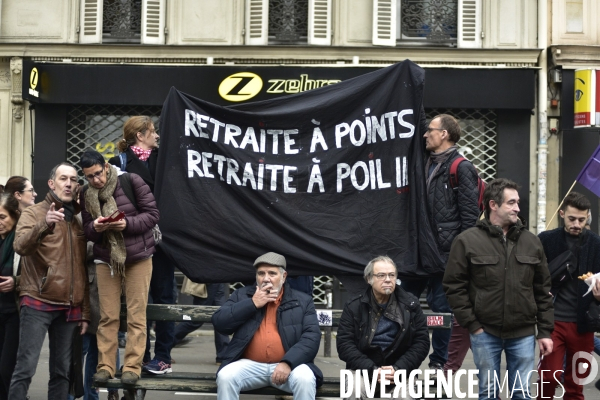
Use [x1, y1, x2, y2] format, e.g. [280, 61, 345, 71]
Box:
[217, 358, 317, 400]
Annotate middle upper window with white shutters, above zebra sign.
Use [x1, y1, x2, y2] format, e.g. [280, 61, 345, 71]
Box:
[246, 0, 331, 45]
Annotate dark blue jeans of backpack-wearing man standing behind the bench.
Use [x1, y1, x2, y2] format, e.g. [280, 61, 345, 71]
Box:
[401, 275, 452, 367]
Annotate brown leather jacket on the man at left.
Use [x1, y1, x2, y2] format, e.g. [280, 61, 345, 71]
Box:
[13, 193, 90, 321]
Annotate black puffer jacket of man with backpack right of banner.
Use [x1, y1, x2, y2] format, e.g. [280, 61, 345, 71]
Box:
[427, 151, 480, 260]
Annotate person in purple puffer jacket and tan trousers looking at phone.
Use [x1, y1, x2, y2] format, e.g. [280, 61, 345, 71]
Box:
[79, 150, 159, 385]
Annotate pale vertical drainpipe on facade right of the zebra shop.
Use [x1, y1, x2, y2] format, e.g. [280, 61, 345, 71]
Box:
[536, 0, 548, 234]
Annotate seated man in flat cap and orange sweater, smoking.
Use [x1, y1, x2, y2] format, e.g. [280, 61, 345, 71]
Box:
[212, 253, 323, 400]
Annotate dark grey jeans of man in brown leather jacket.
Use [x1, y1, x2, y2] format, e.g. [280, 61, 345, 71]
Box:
[9, 307, 77, 400]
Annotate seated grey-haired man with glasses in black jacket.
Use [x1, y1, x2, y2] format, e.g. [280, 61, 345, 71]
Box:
[337, 256, 429, 399]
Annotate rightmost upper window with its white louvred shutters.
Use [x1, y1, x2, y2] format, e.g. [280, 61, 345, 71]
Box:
[373, 0, 481, 48]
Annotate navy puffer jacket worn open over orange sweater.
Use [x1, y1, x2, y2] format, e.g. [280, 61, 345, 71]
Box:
[211, 283, 323, 387]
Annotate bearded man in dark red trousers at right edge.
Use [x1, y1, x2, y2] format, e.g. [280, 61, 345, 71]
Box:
[538, 192, 600, 400]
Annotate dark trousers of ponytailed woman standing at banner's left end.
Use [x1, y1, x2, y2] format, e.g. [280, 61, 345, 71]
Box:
[144, 246, 175, 364]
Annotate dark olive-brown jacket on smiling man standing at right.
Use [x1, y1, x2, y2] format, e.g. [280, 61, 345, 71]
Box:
[443, 218, 554, 339]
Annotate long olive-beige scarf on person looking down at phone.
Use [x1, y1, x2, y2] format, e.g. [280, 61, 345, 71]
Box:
[85, 165, 127, 276]
